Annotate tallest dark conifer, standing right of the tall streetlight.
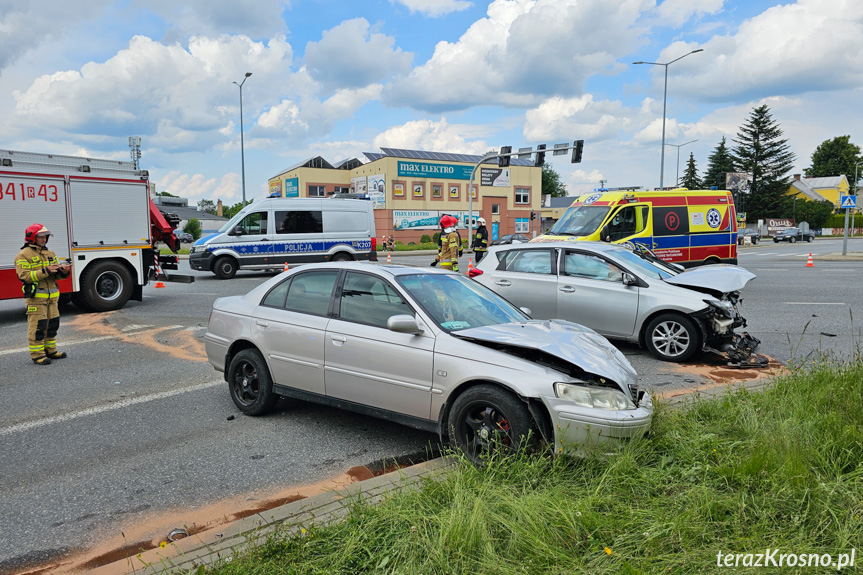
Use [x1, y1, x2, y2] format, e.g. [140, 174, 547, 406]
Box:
[732, 104, 794, 221]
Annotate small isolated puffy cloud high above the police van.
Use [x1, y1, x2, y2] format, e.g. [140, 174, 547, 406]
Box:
[304, 18, 412, 89]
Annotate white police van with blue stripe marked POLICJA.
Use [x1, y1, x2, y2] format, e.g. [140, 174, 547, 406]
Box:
[189, 197, 378, 279]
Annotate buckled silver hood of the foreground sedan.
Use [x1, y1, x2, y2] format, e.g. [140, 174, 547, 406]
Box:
[450, 319, 638, 396]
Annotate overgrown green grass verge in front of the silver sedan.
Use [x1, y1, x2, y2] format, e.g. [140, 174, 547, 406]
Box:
[179, 354, 863, 575]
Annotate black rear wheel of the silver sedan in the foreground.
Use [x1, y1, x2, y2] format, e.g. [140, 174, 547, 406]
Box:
[228, 349, 279, 416]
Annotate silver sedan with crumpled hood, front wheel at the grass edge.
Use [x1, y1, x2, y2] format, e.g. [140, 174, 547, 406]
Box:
[204, 262, 653, 461]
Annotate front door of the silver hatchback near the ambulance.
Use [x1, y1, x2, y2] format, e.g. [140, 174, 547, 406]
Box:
[557, 249, 639, 337]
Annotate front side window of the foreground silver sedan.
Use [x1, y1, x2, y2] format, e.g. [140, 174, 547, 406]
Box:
[339, 272, 414, 327]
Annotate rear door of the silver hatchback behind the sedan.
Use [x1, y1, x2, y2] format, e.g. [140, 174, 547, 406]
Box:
[480, 246, 558, 319]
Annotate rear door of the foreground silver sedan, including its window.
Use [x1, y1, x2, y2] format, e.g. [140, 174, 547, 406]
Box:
[252, 270, 339, 395]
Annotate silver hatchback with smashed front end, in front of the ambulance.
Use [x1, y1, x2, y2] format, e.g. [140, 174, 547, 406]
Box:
[469, 242, 767, 367]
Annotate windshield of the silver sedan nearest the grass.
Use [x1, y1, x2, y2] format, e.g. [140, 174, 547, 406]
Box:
[397, 274, 530, 332]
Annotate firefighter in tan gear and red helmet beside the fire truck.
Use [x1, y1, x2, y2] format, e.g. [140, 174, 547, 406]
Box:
[15, 224, 70, 365]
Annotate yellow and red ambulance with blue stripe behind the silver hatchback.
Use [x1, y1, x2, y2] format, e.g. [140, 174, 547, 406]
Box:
[531, 188, 737, 267]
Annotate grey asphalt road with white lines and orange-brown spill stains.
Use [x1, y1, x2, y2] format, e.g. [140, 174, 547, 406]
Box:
[0, 239, 863, 573]
